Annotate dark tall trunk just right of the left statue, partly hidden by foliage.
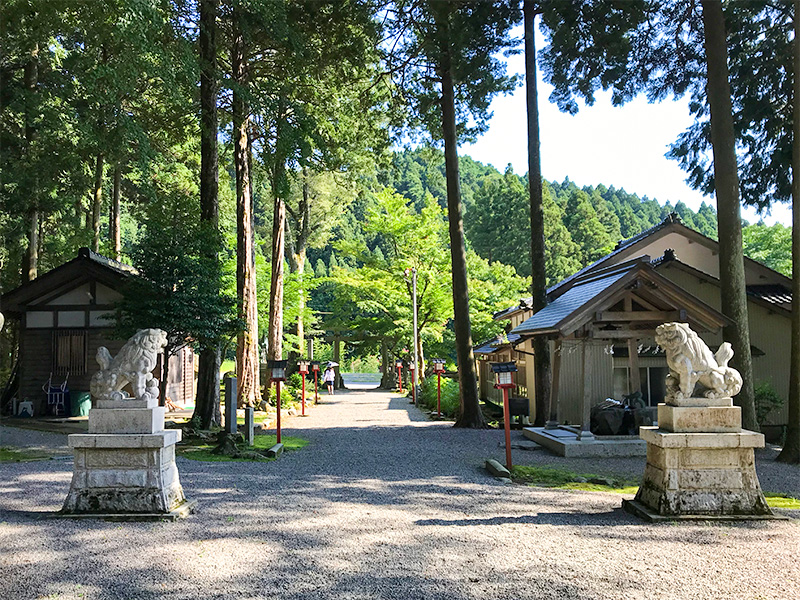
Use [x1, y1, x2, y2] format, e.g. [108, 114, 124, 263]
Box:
[192, 0, 222, 429]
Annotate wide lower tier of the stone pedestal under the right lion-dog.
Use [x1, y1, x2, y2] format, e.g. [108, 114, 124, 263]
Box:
[636, 427, 772, 517]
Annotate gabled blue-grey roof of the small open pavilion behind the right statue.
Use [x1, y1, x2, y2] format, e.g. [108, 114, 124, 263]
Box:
[511, 256, 728, 337]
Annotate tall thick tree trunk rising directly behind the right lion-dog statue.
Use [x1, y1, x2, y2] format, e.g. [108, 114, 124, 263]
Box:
[702, 0, 759, 431]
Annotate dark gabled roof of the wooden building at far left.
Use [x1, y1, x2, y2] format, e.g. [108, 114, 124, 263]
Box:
[0, 248, 138, 314]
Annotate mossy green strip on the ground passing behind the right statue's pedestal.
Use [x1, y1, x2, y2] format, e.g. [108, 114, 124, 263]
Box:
[511, 466, 800, 510]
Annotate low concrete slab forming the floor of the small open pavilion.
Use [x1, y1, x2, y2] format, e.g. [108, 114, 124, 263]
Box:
[522, 427, 647, 458]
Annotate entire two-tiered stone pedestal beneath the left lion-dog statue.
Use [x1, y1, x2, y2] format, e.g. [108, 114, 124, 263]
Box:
[61, 399, 187, 516]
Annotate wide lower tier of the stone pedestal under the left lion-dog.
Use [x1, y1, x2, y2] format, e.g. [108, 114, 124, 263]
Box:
[61, 430, 186, 515]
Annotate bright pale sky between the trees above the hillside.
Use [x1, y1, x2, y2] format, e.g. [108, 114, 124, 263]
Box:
[459, 31, 791, 225]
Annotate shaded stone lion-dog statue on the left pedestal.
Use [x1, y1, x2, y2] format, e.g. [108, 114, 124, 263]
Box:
[90, 329, 167, 400]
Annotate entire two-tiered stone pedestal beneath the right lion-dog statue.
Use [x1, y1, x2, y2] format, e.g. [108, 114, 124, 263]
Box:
[623, 398, 772, 520]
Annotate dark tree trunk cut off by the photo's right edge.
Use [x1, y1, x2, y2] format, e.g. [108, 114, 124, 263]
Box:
[777, 0, 800, 464]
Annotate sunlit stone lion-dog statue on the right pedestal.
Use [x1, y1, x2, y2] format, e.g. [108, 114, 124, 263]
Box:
[656, 323, 742, 403]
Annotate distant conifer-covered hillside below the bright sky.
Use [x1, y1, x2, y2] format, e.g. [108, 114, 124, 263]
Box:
[310, 147, 717, 284]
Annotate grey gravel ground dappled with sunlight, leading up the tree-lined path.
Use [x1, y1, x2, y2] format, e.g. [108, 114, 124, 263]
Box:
[0, 392, 800, 600]
